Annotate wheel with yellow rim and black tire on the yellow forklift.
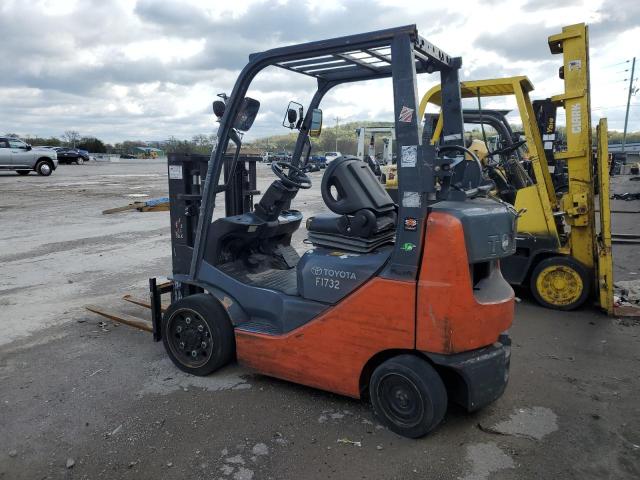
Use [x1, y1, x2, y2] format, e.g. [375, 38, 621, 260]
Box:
[530, 257, 590, 310]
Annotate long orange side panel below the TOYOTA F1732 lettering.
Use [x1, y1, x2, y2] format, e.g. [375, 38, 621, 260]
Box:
[236, 278, 415, 398]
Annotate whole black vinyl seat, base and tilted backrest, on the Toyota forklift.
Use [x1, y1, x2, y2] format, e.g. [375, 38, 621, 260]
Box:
[307, 156, 397, 252]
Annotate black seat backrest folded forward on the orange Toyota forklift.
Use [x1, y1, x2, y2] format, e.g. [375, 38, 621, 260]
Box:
[320, 156, 395, 215]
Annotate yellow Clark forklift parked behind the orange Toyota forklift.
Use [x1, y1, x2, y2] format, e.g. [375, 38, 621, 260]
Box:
[404, 24, 613, 313]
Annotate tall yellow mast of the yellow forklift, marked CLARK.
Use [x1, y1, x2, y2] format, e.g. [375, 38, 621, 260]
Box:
[549, 23, 613, 313]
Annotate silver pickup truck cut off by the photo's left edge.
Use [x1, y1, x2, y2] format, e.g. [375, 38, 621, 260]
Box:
[0, 137, 58, 177]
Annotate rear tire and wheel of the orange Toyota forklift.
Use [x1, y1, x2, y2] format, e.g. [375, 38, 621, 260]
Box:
[369, 355, 447, 438]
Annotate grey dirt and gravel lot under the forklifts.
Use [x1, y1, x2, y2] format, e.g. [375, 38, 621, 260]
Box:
[0, 161, 640, 480]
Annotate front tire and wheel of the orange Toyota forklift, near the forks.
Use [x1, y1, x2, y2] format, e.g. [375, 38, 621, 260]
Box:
[162, 293, 235, 376]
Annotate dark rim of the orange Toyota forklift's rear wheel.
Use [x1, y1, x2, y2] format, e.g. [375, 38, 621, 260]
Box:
[377, 373, 424, 428]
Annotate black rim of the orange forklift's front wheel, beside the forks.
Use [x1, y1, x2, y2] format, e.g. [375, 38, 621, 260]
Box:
[166, 309, 214, 368]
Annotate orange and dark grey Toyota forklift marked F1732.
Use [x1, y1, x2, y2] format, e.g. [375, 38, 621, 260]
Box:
[150, 25, 516, 438]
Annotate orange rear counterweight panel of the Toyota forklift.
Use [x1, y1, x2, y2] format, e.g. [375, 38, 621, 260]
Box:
[416, 212, 514, 354]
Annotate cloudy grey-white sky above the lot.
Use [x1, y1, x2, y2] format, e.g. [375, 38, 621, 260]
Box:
[0, 0, 640, 142]
